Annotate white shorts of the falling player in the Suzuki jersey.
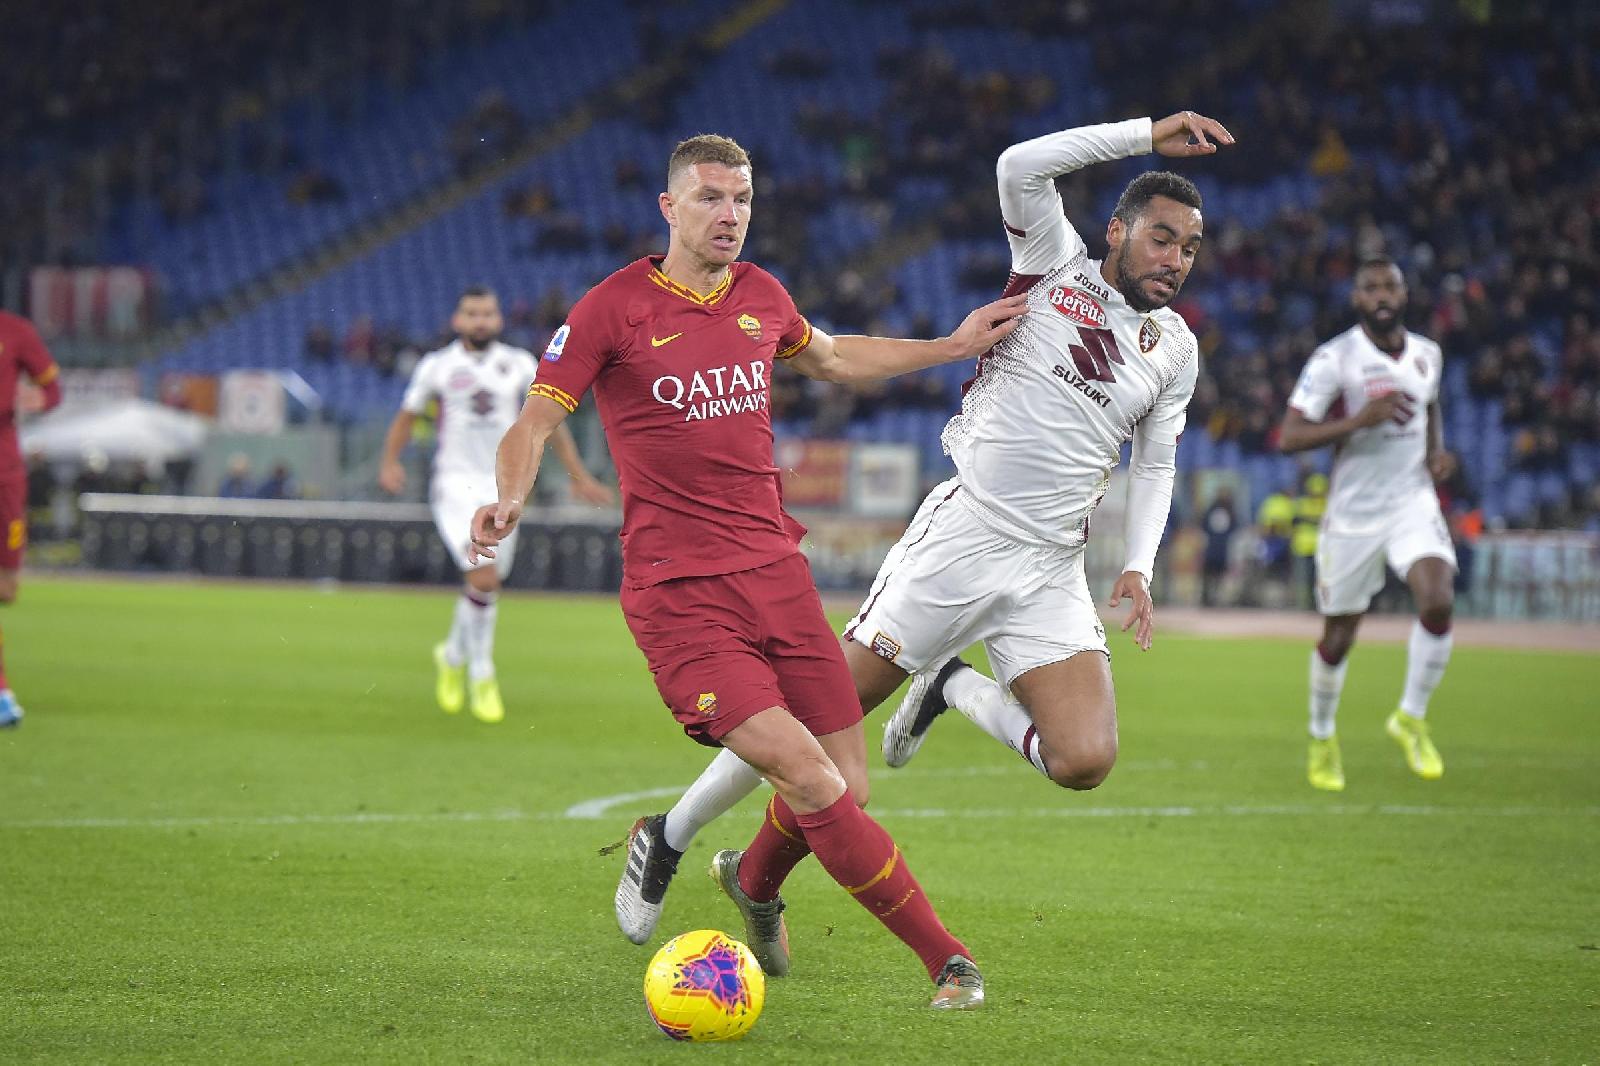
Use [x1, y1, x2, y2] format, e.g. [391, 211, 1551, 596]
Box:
[845, 479, 1110, 690]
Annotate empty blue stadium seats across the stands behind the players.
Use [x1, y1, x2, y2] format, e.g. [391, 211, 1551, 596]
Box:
[50, 0, 1600, 523]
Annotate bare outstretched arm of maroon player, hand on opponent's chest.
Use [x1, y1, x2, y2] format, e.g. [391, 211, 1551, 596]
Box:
[784, 296, 1027, 384]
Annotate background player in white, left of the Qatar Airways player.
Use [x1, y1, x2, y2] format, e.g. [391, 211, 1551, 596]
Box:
[378, 287, 611, 722]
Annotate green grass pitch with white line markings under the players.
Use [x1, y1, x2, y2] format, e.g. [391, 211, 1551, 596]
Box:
[0, 576, 1600, 1064]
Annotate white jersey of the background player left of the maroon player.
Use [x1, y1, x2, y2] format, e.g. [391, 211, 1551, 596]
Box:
[400, 341, 539, 490]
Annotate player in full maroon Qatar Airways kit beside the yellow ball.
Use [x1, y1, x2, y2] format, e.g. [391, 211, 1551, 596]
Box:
[469, 134, 1026, 1008]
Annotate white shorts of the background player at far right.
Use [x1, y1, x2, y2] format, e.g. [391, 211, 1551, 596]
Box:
[1317, 493, 1456, 615]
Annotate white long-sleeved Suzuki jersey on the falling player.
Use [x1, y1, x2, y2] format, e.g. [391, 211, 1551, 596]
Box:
[944, 120, 1200, 546]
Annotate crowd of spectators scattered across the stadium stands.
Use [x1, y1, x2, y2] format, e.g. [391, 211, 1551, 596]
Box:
[15, 0, 1600, 527]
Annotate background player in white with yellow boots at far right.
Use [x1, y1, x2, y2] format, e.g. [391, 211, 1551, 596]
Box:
[1278, 258, 1456, 792]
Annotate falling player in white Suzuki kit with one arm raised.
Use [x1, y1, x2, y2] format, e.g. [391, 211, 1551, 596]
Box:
[616, 112, 1234, 943]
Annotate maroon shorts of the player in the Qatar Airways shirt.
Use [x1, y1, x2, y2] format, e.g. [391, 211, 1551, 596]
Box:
[621, 552, 861, 747]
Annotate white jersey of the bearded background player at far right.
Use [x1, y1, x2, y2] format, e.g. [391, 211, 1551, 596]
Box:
[1290, 325, 1445, 535]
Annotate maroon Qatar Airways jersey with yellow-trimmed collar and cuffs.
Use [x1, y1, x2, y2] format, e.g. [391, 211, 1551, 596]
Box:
[528, 256, 811, 589]
